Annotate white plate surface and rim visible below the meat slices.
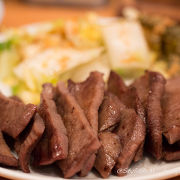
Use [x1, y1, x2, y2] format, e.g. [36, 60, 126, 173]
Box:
[0, 157, 180, 180]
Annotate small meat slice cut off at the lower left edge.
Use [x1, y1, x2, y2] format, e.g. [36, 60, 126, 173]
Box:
[0, 132, 18, 167]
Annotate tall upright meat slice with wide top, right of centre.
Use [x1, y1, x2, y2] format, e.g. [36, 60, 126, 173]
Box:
[131, 71, 166, 159]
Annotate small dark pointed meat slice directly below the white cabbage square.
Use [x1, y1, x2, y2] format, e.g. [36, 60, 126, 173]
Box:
[108, 71, 127, 99]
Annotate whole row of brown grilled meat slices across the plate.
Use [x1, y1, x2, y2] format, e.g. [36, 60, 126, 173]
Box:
[0, 71, 180, 178]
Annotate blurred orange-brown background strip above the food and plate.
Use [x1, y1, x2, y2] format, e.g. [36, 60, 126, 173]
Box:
[0, 0, 180, 27]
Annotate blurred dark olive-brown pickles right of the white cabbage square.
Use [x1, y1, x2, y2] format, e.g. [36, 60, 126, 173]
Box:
[139, 14, 180, 77]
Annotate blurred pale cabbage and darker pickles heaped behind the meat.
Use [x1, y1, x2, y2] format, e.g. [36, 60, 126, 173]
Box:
[0, 13, 180, 104]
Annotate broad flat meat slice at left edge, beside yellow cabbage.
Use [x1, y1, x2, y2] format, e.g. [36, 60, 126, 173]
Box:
[0, 94, 36, 138]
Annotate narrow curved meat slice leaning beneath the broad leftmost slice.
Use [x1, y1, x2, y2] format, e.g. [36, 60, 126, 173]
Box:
[18, 113, 45, 173]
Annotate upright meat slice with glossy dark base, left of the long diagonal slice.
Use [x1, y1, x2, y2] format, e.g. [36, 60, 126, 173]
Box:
[34, 83, 68, 165]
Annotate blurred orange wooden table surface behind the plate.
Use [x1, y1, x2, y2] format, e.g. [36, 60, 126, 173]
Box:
[0, 0, 180, 180]
